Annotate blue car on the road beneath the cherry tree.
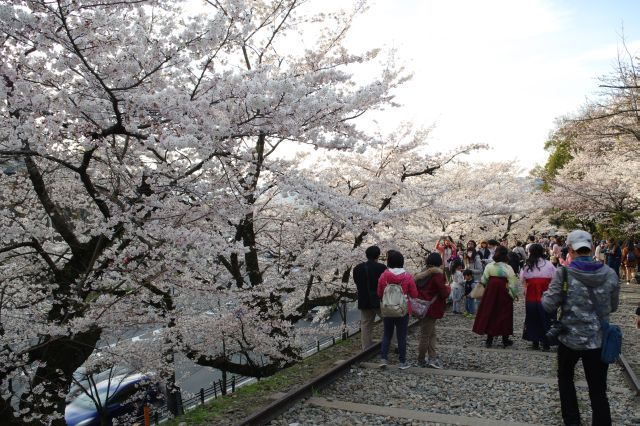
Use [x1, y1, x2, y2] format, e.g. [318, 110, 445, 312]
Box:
[64, 374, 160, 426]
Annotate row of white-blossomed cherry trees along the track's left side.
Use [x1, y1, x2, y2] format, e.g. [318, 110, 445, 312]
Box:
[0, 0, 552, 424]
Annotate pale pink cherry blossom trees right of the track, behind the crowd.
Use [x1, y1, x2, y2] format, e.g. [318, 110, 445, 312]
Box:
[543, 48, 640, 236]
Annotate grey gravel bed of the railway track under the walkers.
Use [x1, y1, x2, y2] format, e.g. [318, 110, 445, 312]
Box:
[270, 286, 640, 426]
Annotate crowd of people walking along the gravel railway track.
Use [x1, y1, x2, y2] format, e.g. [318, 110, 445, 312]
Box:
[353, 230, 624, 425]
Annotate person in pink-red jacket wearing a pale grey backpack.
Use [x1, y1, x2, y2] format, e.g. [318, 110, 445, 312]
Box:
[378, 250, 418, 370]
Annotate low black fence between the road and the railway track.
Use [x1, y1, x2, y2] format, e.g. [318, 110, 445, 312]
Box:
[134, 329, 360, 425]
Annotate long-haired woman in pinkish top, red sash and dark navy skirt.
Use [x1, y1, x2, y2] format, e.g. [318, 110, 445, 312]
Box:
[520, 244, 556, 351]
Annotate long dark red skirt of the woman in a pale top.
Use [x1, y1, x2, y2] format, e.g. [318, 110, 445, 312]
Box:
[473, 277, 513, 336]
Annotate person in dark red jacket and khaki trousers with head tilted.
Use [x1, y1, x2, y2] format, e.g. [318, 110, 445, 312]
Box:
[415, 253, 451, 368]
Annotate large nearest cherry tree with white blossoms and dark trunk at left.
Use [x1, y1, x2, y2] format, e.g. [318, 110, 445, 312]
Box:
[0, 0, 403, 424]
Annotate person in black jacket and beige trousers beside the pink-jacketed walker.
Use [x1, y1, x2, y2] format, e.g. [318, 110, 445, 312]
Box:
[353, 246, 387, 350]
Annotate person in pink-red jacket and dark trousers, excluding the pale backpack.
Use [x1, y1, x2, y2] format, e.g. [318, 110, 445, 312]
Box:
[377, 250, 418, 370]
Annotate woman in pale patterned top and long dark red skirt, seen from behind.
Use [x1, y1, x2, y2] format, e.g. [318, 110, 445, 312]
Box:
[473, 246, 518, 348]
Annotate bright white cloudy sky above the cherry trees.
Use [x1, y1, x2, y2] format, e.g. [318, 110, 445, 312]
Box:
[340, 0, 640, 169]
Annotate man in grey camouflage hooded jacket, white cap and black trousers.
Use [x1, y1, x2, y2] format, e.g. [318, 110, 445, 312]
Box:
[542, 230, 620, 425]
